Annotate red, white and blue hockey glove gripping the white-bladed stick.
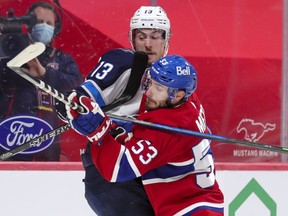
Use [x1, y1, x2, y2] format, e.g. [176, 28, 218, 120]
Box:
[65, 92, 111, 142]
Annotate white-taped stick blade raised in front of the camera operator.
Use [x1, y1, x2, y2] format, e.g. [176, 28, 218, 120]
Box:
[7, 42, 46, 69]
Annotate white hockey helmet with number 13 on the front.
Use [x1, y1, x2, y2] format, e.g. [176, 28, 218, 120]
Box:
[129, 6, 171, 52]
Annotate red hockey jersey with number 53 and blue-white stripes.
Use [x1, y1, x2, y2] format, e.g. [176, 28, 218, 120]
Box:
[91, 93, 224, 216]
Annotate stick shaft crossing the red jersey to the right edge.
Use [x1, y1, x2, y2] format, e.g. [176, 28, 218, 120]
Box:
[108, 114, 288, 154]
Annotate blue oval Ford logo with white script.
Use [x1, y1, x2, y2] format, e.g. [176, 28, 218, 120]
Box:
[0, 115, 54, 154]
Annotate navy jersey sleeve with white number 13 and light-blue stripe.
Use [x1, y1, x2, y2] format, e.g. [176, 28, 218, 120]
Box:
[78, 49, 134, 107]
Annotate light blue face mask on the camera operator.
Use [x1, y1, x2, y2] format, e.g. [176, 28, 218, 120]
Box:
[31, 23, 54, 45]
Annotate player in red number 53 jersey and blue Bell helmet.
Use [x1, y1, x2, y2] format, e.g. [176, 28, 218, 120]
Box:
[66, 55, 224, 216]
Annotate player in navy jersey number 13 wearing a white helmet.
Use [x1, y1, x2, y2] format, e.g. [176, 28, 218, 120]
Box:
[70, 6, 171, 216]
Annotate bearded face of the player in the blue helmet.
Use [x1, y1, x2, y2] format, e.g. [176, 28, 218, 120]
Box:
[145, 79, 168, 110]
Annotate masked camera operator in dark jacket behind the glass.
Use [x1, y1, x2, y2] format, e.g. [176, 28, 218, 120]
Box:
[0, 2, 83, 161]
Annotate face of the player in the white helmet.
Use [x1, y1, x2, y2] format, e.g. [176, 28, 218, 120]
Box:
[134, 29, 165, 65]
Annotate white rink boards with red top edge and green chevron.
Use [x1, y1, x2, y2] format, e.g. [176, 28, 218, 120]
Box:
[0, 162, 288, 216]
